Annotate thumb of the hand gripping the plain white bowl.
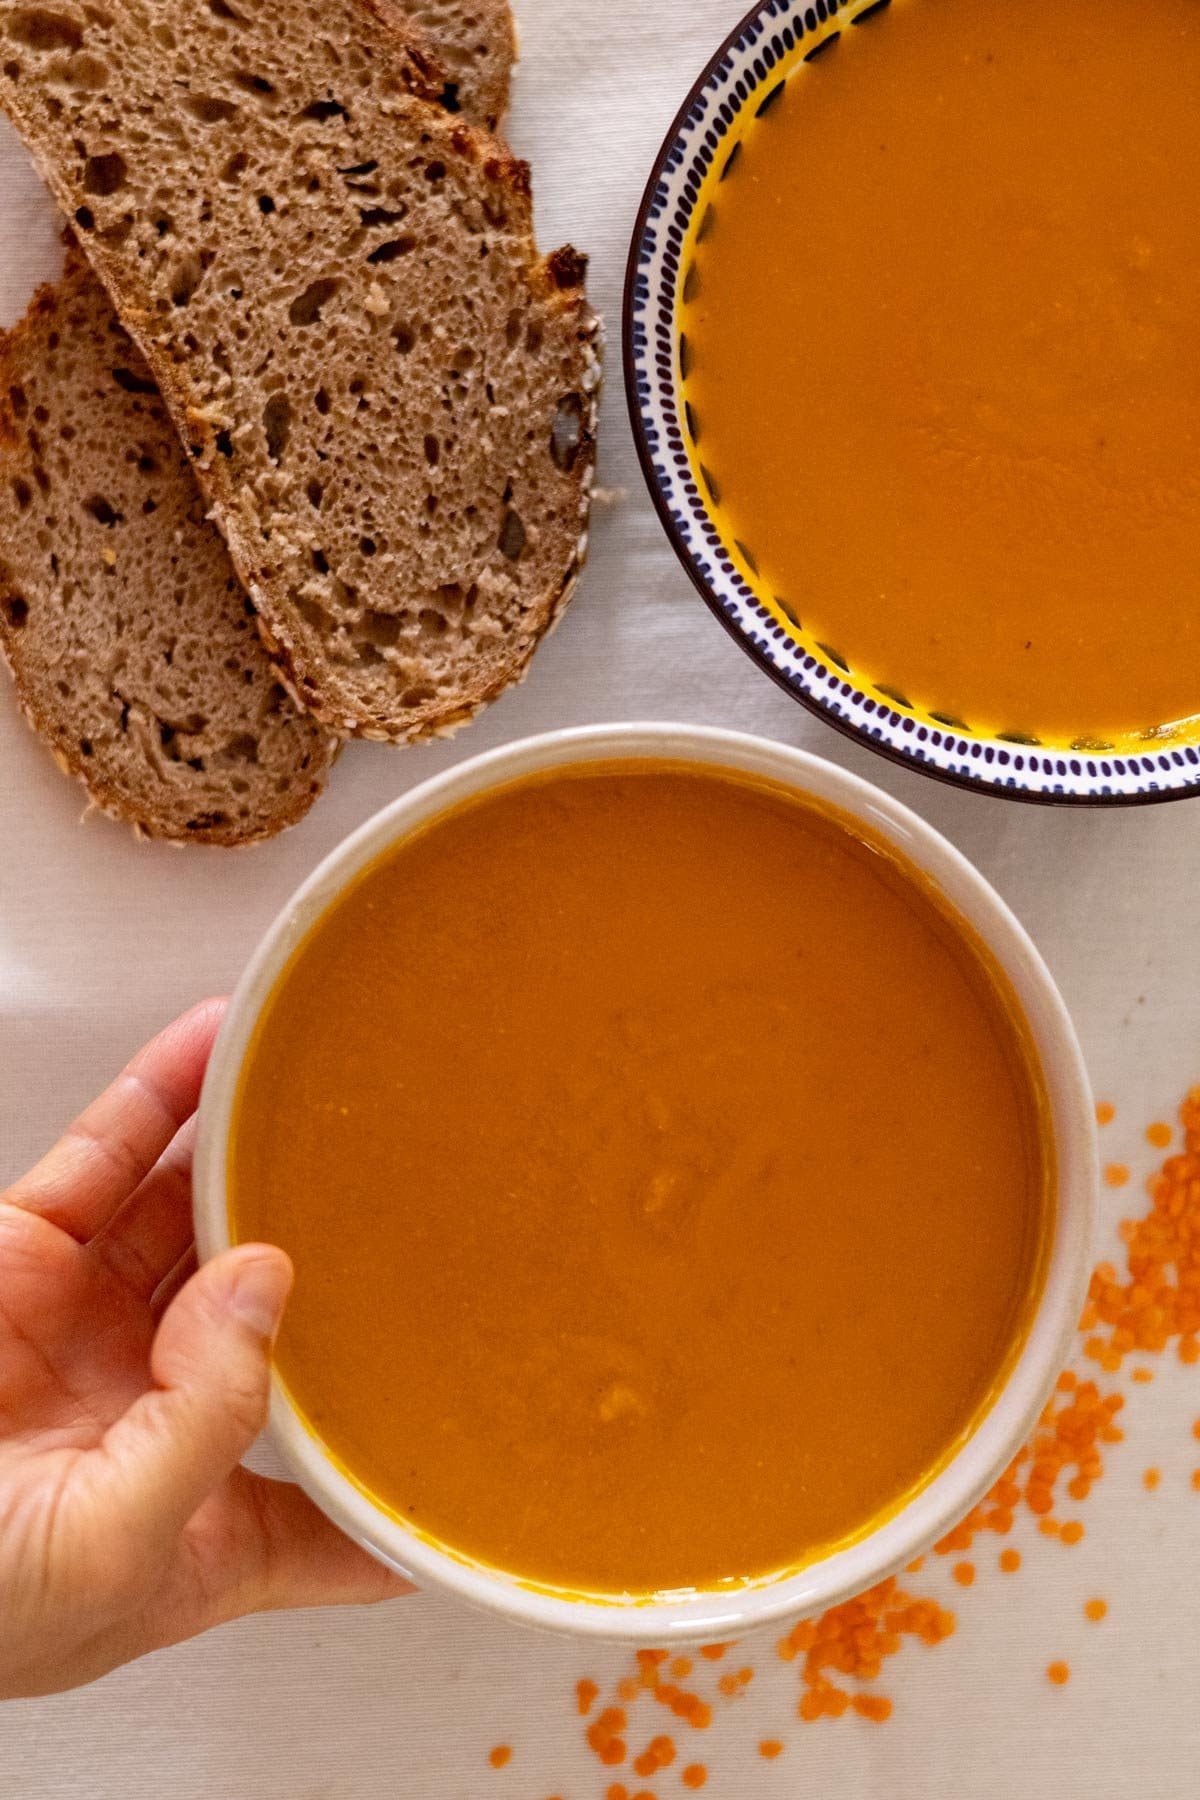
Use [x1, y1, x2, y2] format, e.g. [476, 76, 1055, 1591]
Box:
[104, 1244, 291, 1535]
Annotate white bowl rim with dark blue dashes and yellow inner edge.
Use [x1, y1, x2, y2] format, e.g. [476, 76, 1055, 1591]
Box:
[622, 0, 1200, 806]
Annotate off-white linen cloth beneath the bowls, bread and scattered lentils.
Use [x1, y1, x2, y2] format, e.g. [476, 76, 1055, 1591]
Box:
[0, 0, 1200, 1800]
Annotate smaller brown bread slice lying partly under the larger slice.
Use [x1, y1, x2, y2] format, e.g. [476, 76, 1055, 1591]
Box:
[0, 252, 336, 844]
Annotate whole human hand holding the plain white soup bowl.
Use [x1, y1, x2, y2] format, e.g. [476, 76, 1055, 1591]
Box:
[0, 1001, 408, 1697]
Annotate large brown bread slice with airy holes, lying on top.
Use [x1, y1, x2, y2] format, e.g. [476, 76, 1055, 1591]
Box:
[0, 0, 599, 740]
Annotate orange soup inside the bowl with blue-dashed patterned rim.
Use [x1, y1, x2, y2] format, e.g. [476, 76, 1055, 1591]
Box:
[680, 0, 1200, 745]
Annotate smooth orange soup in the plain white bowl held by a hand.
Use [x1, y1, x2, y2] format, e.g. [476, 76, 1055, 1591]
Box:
[228, 761, 1052, 1593]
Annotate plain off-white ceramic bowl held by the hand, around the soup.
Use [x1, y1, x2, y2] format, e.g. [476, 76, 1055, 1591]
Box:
[194, 724, 1096, 1643]
